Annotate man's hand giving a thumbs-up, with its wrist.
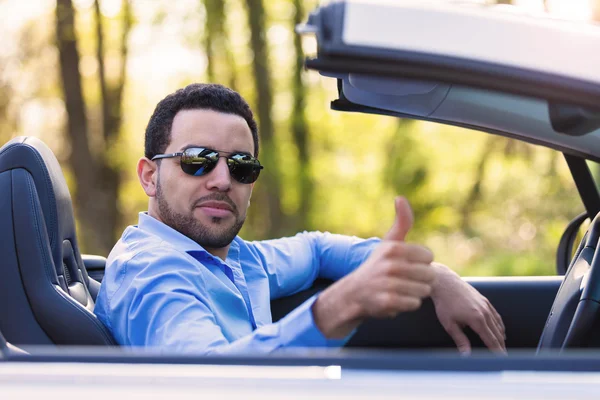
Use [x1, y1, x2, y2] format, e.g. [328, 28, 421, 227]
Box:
[313, 197, 436, 338]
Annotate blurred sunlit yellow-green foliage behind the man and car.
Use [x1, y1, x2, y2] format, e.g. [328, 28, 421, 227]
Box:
[0, 0, 583, 275]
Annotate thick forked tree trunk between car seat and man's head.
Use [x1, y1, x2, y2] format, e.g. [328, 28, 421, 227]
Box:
[56, 0, 131, 255]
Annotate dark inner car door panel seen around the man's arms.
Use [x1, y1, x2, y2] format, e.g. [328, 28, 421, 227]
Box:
[271, 276, 562, 348]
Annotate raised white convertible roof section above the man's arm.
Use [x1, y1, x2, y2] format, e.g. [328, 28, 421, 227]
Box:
[298, 0, 600, 161]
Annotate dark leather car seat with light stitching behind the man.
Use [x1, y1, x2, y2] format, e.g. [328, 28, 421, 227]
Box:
[0, 137, 115, 346]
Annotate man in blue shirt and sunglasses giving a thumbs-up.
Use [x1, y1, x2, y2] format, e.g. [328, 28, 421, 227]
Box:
[95, 84, 505, 354]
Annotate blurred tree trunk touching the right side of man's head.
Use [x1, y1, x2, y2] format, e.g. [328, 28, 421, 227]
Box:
[246, 0, 285, 237]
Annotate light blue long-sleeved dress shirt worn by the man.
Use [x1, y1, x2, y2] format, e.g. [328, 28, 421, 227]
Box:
[94, 213, 379, 354]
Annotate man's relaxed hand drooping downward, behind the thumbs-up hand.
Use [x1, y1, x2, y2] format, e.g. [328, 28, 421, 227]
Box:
[431, 263, 506, 354]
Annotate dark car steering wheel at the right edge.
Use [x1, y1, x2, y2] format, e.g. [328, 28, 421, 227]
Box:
[538, 214, 600, 353]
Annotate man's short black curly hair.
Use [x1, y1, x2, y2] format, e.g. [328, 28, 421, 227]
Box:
[144, 83, 258, 159]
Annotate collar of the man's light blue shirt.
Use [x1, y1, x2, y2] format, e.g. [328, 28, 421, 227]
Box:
[138, 212, 242, 263]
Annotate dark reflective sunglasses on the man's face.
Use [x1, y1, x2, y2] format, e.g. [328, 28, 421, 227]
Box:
[152, 147, 263, 183]
